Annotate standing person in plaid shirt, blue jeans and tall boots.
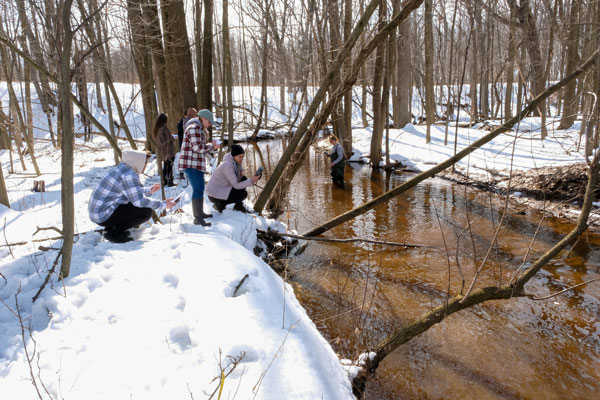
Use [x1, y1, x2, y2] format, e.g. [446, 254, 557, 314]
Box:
[177, 109, 219, 226]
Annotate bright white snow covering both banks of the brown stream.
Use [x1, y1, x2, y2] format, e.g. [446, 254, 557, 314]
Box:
[0, 81, 598, 400]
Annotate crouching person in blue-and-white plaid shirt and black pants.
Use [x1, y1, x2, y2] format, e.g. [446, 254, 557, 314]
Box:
[88, 150, 175, 243]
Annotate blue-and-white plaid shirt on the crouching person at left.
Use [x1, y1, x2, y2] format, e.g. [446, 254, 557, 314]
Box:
[88, 163, 166, 224]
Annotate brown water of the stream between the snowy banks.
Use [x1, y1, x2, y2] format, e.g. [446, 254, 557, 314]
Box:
[245, 141, 600, 399]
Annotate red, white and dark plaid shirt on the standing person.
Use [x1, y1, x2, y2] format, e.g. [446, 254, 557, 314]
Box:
[177, 118, 213, 172]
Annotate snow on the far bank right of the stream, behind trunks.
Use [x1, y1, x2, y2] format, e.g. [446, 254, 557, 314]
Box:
[344, 117, 586, 175]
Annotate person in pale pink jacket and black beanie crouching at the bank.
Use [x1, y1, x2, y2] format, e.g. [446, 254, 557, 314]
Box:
[206, 144, 262, 213]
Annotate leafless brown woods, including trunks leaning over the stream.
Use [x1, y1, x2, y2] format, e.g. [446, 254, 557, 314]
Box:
[0, 0, 600, 397]
